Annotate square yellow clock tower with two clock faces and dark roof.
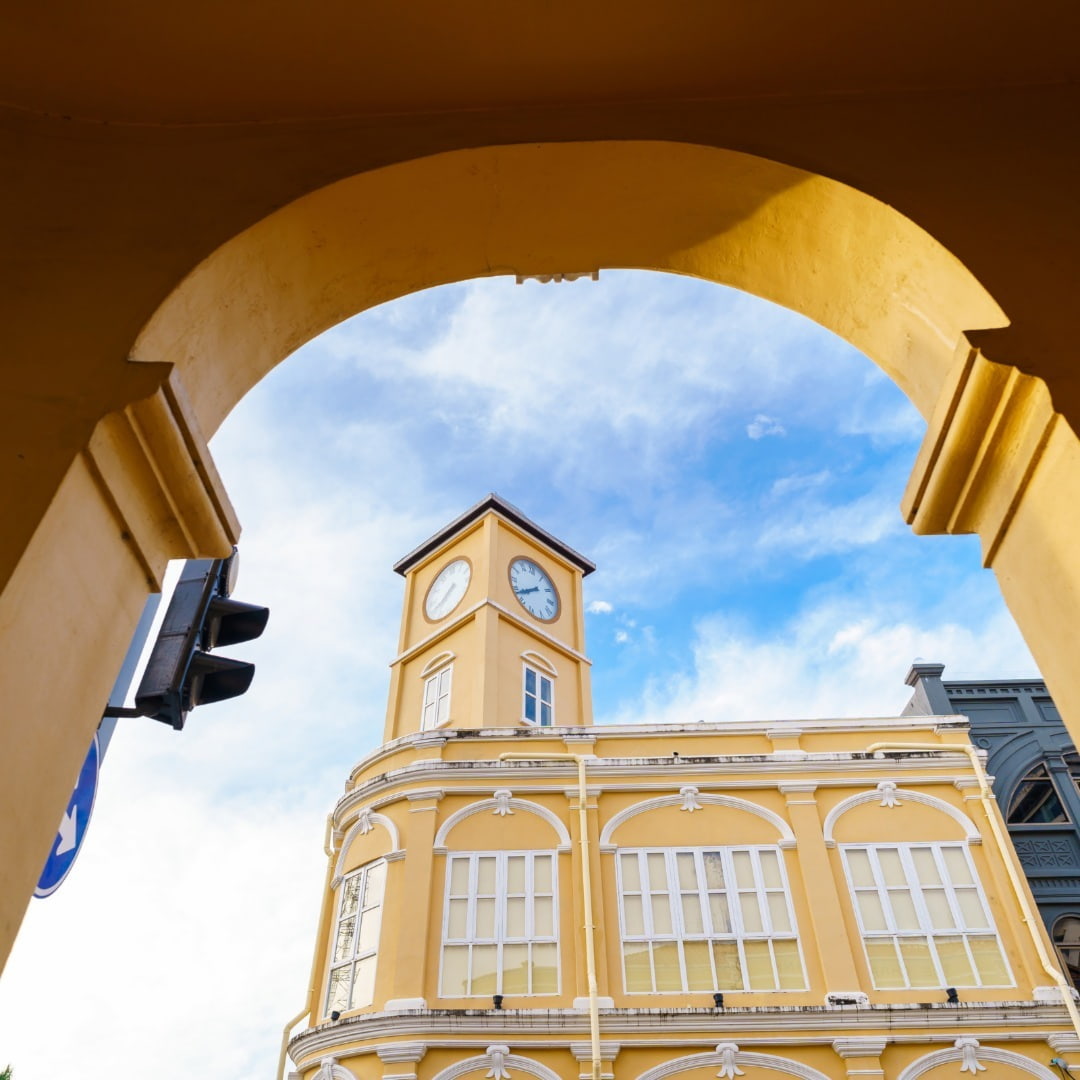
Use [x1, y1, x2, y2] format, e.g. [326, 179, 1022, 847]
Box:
[384, 495, 595, 742]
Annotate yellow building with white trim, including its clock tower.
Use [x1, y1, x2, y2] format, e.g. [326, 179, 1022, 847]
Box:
[288, 496, 1080, 1080]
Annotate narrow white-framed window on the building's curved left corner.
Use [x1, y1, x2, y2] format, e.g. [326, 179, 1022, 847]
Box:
[326, 860, 387, 1014]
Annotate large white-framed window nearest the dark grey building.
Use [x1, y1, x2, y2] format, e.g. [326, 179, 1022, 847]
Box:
[841, 843, 1013, 989]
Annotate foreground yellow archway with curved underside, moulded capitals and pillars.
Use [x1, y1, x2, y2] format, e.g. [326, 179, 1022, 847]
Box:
[8, 135, 1080, 972]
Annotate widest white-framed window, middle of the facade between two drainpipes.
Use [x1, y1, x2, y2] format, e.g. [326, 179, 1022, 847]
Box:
[619, 847, 806, 994]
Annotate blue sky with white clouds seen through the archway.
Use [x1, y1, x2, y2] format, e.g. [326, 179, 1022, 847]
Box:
[0, 271, 1035, 1080]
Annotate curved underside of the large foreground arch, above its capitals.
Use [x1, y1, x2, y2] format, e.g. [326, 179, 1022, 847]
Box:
[132, 141, 1007, 434]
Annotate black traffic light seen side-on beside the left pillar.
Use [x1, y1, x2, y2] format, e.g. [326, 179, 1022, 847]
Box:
[135, 549, 270, 731]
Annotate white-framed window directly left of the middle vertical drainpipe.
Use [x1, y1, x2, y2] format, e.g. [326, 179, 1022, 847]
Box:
[438, 851, 558, 998]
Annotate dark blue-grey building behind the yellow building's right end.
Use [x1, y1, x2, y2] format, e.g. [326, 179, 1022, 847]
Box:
[903, 662, 1080, 987]
